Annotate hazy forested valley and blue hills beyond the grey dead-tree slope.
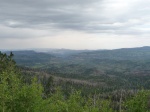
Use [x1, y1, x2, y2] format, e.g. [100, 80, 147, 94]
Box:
[10, 47, 150, 92]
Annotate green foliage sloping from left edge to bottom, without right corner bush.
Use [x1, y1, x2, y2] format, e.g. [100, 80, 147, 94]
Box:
[0, 53, 112, 112]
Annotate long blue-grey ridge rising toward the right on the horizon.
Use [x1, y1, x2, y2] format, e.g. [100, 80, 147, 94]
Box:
[72, 47, 150, 60]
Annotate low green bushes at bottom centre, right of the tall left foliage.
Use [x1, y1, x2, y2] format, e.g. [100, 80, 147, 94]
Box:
[44, 90, 99, 112]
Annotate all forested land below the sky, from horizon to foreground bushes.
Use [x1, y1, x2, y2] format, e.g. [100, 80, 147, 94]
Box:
[0, 47, 150, 112]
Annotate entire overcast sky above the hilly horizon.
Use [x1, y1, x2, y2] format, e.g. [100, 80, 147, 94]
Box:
[0, 0, 150, 50]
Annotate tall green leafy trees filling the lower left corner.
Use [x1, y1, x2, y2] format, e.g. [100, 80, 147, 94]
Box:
[0, 54, 43, 112]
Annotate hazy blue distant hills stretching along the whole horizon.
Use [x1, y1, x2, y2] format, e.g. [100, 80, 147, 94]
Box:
[4, 47, 150, 66]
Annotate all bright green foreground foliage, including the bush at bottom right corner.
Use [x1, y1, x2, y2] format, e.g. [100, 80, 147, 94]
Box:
[0, 53, 150, 112]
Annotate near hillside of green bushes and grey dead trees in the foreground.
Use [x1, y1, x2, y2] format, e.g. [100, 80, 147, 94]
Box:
[0, 50, 150, 112]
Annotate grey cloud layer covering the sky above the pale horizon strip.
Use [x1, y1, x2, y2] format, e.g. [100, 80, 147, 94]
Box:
[0, 0, 150, 49]
